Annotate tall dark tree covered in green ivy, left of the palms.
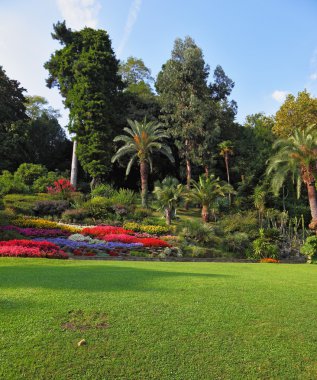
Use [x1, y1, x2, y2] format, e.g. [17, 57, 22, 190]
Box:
[44, 22, 123, 180]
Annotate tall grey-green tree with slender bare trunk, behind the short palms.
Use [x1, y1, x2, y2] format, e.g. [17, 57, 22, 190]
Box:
[156, 37, 209, 189]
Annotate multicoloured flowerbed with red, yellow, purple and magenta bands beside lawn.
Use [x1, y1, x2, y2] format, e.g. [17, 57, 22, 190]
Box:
[0, 223, 170, 258]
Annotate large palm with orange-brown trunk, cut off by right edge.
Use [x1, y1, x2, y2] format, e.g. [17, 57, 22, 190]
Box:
[266, 125, 317, 230]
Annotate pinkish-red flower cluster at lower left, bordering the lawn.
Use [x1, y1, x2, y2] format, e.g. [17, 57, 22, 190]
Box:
[0, 240, 68, 259]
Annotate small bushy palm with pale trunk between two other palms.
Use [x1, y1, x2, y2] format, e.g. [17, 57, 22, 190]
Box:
[153, 177, 184, 225]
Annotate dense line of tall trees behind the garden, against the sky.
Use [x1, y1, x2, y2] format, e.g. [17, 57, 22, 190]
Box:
[0, 22, 317, 221]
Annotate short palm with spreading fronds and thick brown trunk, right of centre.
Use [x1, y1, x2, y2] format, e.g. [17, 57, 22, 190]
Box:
[186, 174, 233, 222]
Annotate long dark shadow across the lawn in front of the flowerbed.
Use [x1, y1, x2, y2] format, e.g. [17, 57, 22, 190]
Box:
[0, 263, 229, 292]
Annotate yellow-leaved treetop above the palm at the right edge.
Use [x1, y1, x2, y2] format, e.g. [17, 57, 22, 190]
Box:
[273, 90, 317, 138]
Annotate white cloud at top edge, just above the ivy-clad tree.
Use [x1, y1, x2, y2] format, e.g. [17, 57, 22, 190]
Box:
[56, 0, 101, 30]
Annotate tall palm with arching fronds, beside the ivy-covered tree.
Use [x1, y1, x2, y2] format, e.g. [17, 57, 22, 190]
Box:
[111, 118, 174, 207]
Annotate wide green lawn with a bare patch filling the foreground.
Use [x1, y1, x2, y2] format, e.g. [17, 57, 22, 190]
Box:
[0, 258, 317, 380]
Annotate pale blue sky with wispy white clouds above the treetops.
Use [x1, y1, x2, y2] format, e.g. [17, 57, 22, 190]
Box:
[0, 0, 317, 126]
